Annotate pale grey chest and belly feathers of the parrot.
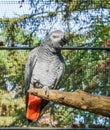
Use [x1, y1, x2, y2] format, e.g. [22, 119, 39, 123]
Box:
[31, 53, 64, 88]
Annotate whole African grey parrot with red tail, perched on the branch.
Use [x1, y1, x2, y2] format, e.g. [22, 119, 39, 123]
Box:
[24, 30, 67, 121]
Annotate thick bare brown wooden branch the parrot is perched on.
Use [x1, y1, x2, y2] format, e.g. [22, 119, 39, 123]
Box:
[28, 88, 110, 117]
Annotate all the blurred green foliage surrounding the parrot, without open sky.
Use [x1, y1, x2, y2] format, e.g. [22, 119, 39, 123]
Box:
[0, 0, 110, 127]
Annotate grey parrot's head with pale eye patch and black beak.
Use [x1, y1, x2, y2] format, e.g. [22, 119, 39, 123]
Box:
[40, 30, 68, 50]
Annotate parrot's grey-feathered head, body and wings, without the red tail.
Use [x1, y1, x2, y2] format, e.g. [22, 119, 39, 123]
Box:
[24, 30, 67, 93]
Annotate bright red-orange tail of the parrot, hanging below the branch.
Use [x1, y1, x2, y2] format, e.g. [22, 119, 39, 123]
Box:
[26, 93, 42, 121]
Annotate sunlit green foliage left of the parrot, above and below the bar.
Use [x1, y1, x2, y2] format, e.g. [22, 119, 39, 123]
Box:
[0, 19, 39, 126]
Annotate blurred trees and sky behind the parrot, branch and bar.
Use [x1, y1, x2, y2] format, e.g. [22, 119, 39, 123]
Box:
[0, 0, 110, 128]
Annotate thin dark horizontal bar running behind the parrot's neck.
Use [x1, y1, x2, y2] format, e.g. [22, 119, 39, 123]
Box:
[0, 46, 110, 51]
